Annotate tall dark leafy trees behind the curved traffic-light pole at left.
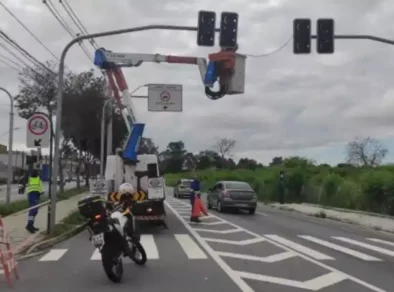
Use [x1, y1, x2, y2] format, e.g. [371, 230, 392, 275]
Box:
[15, 62, 127, 191]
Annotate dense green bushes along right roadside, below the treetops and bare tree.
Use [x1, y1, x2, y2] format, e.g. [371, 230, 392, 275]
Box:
[165, 165, 394, 215]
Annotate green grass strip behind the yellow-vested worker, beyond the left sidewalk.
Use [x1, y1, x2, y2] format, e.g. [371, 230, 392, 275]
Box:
[0, 187, 89, 217]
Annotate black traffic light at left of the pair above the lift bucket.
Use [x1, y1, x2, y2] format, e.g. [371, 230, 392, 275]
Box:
[197, 10, 216, 47]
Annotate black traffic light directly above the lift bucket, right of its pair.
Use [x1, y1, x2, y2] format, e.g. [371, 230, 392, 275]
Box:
[219, 12, 238, 49]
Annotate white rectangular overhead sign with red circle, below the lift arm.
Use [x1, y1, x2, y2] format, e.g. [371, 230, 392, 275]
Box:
[148, 84, 183, 112]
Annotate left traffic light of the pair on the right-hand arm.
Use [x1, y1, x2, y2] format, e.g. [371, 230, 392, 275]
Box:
[293, 18, 311, 54]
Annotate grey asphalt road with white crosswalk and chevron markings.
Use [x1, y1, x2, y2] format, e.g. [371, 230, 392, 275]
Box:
[7, 191, 394, 292]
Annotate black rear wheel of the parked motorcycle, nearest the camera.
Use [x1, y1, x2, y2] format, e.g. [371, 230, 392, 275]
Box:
[101, 245, 123, 283]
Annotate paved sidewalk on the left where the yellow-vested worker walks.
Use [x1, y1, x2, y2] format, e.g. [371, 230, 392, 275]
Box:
[3, 192, 89, 254]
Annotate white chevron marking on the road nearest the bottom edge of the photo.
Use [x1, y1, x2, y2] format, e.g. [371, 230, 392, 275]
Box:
[238, 271, 348, 291]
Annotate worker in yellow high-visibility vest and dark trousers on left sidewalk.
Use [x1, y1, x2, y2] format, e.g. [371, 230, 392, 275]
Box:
[26, 169, 42, 233]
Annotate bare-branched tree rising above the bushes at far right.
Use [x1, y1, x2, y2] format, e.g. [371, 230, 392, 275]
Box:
[346, 137, 388, 167]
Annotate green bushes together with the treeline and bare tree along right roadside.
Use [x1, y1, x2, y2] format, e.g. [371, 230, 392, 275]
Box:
[165, 137, 394, 215]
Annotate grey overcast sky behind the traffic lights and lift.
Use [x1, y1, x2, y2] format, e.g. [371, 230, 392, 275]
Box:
[0, 0, 394, 163]
